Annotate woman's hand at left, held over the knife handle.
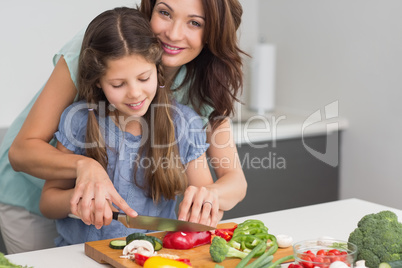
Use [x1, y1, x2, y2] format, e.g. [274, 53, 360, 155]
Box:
[70, 158, 138, 228]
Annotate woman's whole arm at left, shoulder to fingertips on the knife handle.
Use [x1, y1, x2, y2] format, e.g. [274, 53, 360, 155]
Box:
[9, 57, 137, 223]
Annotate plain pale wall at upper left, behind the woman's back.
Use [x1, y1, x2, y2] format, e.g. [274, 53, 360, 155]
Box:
[0, 0, 139, 128]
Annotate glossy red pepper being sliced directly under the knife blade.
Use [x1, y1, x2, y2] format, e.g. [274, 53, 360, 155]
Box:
[163, 231, 211, 249]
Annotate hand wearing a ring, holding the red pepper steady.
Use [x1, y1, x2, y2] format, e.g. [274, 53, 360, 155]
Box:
[178, 185, 223, 227]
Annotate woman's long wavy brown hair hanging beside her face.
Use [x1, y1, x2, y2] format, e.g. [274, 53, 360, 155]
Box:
[140, 0, 249, 127]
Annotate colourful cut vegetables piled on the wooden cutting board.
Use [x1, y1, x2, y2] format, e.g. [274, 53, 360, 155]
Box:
[110, 220, 293, 268]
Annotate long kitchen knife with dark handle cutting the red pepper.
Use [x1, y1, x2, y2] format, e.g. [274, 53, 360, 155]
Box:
[69, 212, 215, 232]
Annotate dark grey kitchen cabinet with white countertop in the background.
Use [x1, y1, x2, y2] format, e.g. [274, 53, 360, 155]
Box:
[218, 108, 348, 219]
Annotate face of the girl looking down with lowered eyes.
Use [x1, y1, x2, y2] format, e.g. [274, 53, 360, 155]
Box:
[97, 54, 158, 123]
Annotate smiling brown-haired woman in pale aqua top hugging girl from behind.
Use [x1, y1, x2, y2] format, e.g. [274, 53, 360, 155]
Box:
[0, 0, 247, 253]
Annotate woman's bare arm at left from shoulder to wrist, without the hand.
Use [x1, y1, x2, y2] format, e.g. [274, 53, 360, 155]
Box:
[9, 58, 84, 179]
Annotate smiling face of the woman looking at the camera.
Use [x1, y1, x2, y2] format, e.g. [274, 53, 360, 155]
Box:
[151, 0, 205, 76]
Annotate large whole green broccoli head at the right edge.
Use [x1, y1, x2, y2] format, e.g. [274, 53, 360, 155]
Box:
[348, 210, 402, 268]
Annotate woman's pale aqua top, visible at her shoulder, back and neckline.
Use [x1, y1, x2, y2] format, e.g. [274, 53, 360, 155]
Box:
[0, 29, 212, 215]
